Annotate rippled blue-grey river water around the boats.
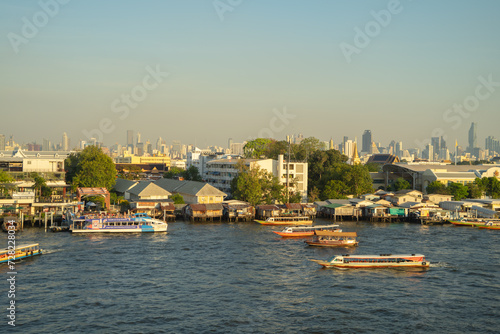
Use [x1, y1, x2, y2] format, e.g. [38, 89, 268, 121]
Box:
[0, 220, 500, 333]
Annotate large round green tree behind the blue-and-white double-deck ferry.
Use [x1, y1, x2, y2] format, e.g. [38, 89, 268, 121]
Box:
[65, 146, 116, 190]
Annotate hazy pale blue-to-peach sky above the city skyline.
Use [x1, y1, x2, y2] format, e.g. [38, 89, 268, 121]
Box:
[0, 0, 500, 148]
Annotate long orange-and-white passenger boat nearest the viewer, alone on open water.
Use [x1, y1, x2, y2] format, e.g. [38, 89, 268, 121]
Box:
[311, 254, 430, 268]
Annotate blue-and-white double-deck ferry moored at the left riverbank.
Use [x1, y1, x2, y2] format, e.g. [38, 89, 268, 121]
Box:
[70, 213, 167, 233]
